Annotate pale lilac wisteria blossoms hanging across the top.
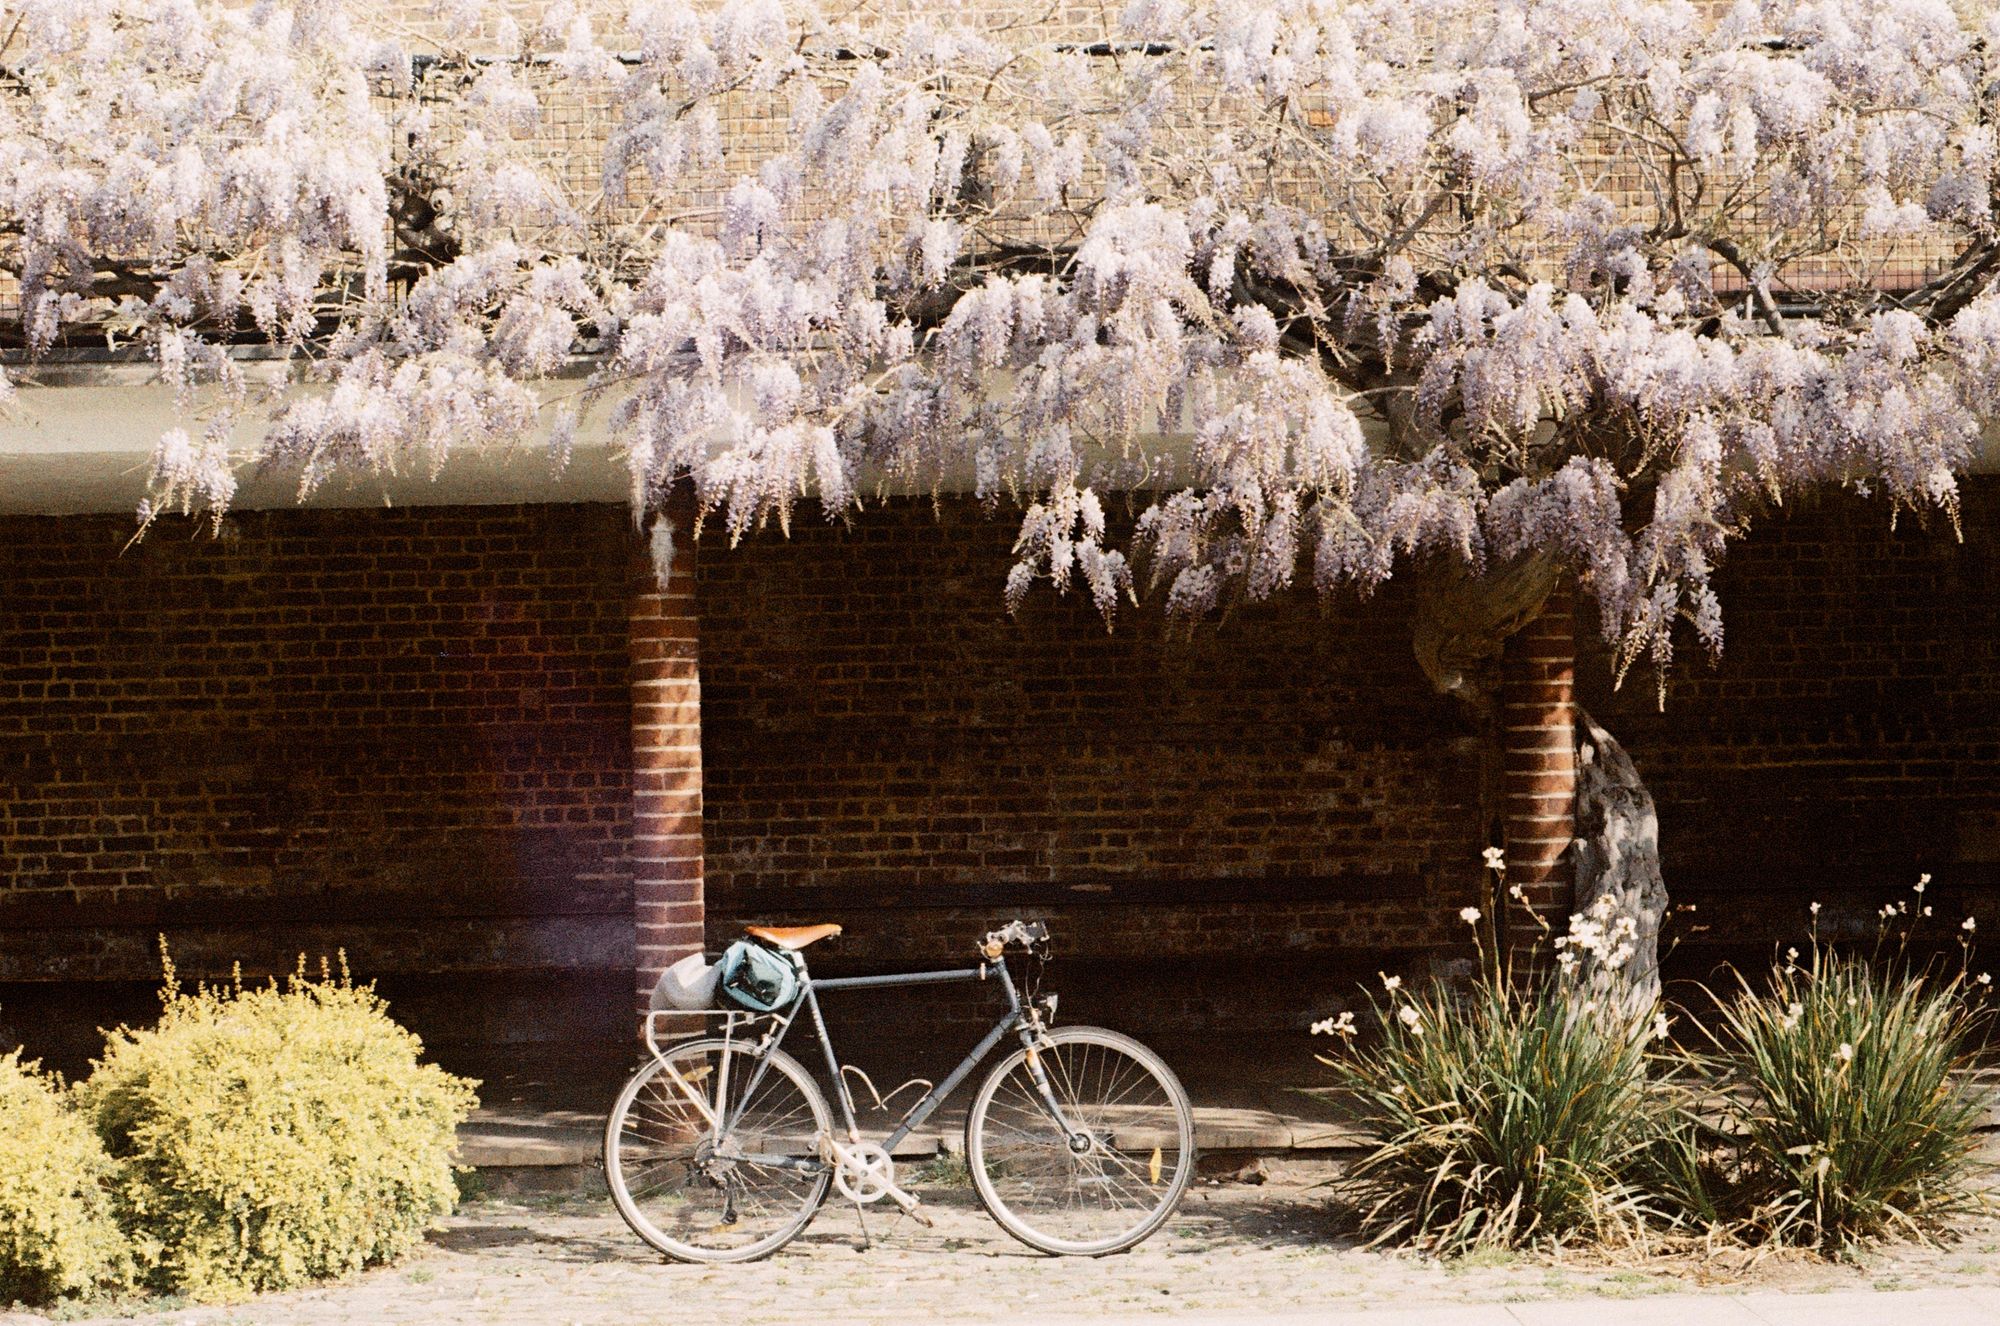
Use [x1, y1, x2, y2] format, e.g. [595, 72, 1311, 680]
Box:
[0, 0, 2000, 668]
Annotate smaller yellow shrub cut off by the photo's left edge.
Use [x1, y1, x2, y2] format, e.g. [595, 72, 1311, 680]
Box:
[0, 1050, 132, 1304]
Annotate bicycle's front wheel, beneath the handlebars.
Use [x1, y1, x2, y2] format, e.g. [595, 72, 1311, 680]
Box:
[966, 1026, 1194, 1256]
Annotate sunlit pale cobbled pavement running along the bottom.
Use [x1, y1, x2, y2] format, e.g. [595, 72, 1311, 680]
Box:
[23, 1182, 2000, 1326]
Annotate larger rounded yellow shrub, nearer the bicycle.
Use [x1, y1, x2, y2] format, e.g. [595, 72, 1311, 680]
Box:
[78, 964, 476, 1300]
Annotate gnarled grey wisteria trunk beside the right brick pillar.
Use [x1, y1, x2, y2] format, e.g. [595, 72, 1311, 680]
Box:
[1574, 710, 1666, 1016]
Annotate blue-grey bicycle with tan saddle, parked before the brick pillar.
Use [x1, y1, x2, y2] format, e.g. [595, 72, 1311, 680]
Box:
[604, 920, 1194, 1262]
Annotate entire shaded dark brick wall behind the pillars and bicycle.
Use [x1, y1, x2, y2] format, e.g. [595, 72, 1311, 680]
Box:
[15, 480, 2000, 1052]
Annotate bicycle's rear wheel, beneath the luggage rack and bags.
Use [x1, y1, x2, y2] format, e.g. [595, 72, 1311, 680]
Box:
[604, 1038, 832, 1262]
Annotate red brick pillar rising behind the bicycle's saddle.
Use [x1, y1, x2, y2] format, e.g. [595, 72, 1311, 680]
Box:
[630, 502, 702, 1014]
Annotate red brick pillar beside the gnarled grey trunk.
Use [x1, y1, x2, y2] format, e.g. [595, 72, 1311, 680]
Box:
[1500, 586, 1576, 960]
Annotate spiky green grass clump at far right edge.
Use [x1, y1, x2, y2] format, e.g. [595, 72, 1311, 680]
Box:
[1710, 892, 1990, 1256]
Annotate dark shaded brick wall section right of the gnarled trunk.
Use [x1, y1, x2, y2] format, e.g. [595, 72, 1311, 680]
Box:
[1578, 478, 2000, 962]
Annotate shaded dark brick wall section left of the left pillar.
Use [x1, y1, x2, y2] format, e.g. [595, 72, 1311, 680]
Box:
[0, 508, 632, 1072]
